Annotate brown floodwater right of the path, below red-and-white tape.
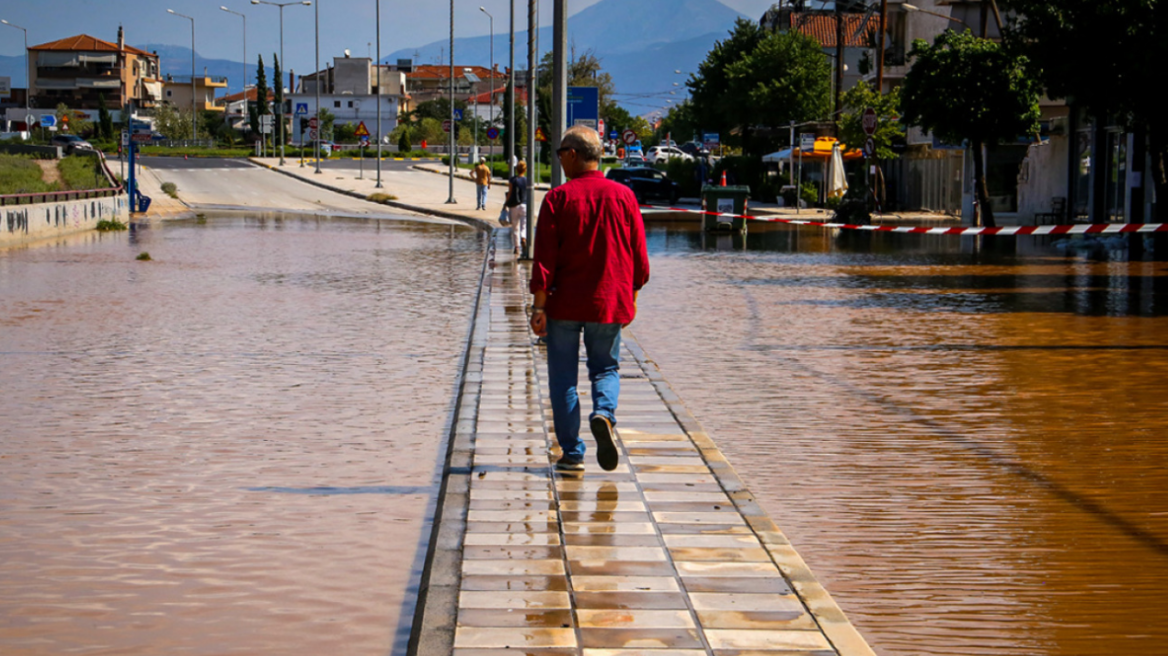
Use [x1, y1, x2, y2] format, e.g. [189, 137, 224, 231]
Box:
[633, 224, 1168, 656]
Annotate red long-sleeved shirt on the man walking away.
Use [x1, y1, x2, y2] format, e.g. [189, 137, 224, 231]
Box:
[531, 170, 649, 323]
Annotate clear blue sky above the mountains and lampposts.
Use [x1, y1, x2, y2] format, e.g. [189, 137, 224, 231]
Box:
[0, 0, 774, 72]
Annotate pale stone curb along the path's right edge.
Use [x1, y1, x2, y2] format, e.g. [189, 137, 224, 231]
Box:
[624, 330, 876, 656]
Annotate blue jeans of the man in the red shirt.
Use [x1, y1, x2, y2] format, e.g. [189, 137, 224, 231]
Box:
[547, 319, 620, 460]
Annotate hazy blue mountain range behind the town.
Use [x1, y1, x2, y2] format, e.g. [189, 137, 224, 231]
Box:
[0, 0, 742, 114]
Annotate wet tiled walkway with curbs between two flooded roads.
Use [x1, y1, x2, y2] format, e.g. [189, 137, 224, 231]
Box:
[413, 231, 872, 656]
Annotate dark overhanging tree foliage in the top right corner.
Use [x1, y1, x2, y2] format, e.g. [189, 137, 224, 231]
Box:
[1006, 0, 1168, 221]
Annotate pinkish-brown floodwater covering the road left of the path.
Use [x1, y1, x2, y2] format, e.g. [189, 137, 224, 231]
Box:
[0, 216, 485, 656]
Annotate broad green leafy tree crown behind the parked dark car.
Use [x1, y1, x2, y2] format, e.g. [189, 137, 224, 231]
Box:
[686, 19, 832, 154]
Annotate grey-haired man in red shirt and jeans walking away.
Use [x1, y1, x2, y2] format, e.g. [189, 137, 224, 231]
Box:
[530, 126, 649, 472]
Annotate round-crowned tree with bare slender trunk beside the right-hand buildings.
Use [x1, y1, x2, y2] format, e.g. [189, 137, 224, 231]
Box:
[902, 30, 1040, 226]
